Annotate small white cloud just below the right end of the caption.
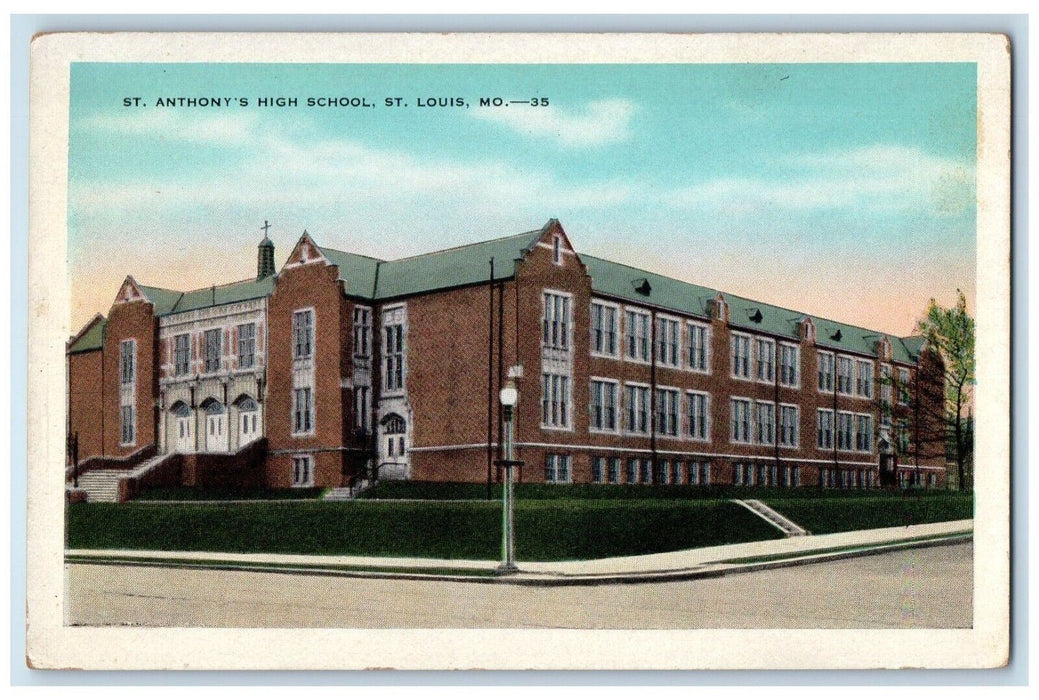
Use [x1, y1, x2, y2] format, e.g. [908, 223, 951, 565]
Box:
[471, 99, 635, 147]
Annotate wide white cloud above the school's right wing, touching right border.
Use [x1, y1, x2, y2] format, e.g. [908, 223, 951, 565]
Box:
[661, 145, 975, 216]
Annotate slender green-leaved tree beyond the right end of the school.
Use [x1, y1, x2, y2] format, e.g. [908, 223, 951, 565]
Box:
[916, 290, 975, 489]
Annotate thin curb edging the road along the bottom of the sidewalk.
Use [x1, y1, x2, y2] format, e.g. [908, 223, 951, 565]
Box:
[65, 532, 974, 588]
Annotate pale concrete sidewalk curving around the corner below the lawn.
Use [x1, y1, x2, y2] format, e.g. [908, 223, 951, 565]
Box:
[65, 520, 974, 586]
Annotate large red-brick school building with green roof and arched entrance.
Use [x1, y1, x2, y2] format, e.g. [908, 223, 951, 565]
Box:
[68, 219, 945, 488]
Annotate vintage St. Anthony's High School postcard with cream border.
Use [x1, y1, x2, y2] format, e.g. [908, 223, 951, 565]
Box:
[26, 32, 1010, 670]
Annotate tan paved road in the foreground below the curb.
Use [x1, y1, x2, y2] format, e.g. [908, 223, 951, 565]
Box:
[66, 543, 974, 629]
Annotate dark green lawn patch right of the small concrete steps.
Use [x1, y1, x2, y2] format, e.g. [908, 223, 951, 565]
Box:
[762, 491, 974, 535]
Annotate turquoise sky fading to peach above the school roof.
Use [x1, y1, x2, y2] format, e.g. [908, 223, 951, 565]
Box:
[69, 63, 977, 334]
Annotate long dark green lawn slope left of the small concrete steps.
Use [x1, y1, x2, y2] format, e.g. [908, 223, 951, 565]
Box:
[66, 500, 779, 561]
